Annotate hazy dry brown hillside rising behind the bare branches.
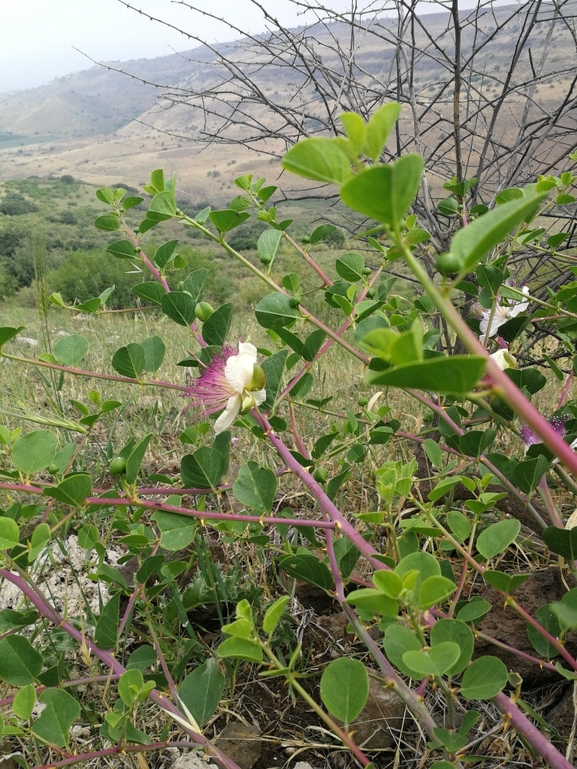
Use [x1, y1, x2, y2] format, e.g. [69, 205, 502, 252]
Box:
[0, 2, 576, 198]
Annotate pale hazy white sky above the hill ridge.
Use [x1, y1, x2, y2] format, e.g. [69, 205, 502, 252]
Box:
[0, 0, 348, 93]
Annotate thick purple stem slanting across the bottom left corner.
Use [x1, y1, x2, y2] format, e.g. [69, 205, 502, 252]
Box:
[0, 569, 240, 769]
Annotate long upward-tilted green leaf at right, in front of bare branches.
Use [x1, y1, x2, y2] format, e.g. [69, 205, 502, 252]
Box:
[451, 193, 547, 270]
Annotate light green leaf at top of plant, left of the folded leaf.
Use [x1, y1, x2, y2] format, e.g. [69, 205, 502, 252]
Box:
[282, 138, 351, 184]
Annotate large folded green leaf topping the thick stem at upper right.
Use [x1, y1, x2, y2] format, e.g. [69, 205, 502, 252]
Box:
[340, 156, 423, 228]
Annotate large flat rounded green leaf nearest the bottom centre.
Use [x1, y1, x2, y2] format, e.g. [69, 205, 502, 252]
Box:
[321, 657, 369, 724]
